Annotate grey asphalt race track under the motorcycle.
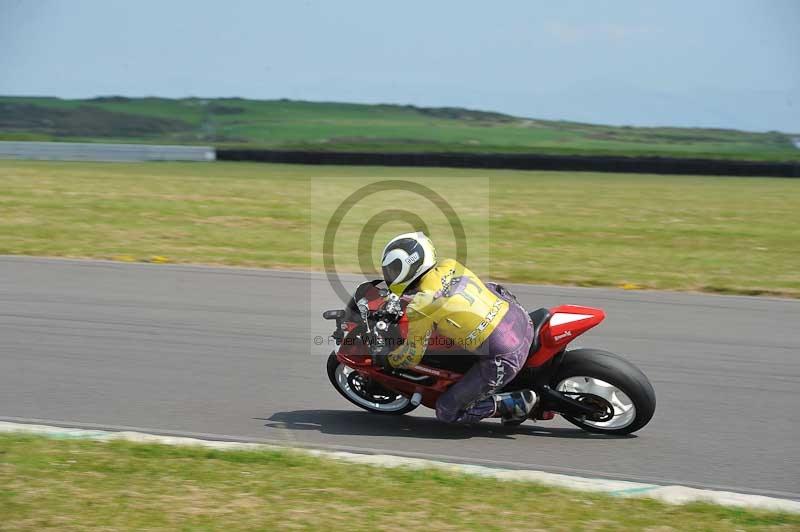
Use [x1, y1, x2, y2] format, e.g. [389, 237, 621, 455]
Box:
[0, 257, 800, 499]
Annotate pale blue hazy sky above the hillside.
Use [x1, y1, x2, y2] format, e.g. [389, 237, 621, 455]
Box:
[0, 0, 800, 133]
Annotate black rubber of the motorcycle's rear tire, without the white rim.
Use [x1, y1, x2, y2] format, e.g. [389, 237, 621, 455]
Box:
[550, 349, 656, 435]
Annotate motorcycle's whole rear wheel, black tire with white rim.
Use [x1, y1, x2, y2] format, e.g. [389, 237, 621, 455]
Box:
[550, 349, 656, 435]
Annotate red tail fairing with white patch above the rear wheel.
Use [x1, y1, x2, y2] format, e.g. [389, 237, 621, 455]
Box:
[526, 305, 606, 368]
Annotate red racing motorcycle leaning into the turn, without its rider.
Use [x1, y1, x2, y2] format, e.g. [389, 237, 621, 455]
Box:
[323, 279, 656, 435]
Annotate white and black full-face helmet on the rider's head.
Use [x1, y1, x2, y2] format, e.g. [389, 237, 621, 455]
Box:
[381, 232, 436, 295]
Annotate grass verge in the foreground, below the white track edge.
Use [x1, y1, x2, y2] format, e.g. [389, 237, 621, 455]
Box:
[0, 434, 800, 531]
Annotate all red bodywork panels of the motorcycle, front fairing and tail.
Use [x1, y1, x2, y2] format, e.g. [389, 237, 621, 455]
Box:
[336, 290, 605, 408]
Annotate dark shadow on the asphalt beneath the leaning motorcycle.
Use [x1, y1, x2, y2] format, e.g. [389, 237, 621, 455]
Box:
[255, 410, 636, 440]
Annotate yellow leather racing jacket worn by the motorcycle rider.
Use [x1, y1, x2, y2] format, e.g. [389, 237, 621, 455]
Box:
[389, 259, 508, 367]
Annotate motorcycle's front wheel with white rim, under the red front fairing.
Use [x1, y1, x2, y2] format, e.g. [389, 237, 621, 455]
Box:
[327, 353, 419, 416]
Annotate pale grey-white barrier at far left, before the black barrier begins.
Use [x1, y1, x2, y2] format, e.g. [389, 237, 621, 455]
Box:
[0, 141, 217, 162]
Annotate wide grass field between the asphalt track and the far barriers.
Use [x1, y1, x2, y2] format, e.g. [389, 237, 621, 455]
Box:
[0, 161, 800, 297]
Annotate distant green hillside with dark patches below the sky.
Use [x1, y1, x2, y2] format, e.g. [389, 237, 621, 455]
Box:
[0, 96, 800, 160]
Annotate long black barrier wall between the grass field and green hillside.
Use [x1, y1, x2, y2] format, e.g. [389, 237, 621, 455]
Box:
[217, 148, 800, 177]
